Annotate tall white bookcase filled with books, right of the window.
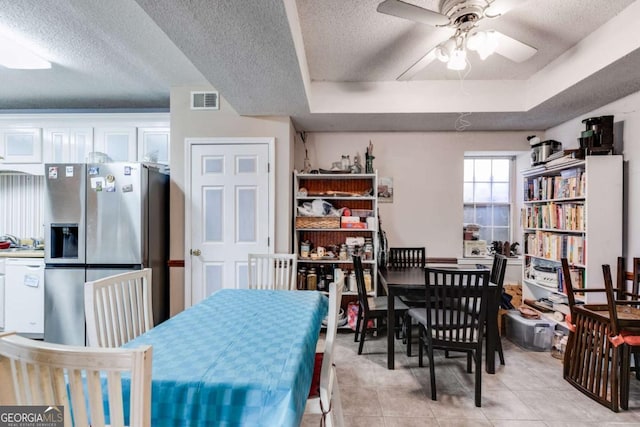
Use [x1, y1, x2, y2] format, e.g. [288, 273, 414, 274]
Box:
[521, 155, 623, 309]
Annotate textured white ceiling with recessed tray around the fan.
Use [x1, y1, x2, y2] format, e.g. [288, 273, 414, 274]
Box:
[0, 0, 640, 131]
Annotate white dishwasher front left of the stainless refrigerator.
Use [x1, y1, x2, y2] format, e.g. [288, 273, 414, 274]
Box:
[4, 258, 44, 338]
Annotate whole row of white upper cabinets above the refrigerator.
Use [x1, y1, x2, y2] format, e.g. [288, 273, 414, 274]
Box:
[0, 113, 170, 175]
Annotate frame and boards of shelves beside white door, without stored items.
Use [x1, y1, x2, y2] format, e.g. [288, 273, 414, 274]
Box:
[293, 173, 378, 296]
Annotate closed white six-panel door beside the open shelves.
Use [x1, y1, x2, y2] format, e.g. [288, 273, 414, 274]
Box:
[185, 143, 272, 305]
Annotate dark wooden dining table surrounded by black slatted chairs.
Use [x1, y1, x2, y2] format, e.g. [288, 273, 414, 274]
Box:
[378, 267, 500, 374]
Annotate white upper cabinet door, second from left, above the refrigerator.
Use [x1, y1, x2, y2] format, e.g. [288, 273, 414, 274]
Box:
[43, 127, 93, 163]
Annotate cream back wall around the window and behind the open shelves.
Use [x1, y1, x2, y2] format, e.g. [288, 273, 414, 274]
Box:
[302, 132, 535, 258]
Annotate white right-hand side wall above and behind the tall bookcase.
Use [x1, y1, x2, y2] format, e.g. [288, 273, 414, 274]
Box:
[546, 92, 640, 260]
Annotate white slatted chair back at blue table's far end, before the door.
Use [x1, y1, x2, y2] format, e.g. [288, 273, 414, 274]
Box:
[247, 254, 298, 291]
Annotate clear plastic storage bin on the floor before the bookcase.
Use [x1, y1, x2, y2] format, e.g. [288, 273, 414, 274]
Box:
[505, 310, 556, 351]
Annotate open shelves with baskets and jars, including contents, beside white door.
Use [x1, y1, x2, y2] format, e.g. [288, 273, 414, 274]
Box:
[293, 173, 378, 298]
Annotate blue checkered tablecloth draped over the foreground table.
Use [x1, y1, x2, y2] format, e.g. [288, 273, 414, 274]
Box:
[126, 289, 327, 427]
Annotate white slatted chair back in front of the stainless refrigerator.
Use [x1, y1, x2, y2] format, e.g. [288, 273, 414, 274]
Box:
[84, 268, 153, 347]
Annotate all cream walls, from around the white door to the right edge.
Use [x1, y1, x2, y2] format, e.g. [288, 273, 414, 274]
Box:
[171, 88, 640, 313]
